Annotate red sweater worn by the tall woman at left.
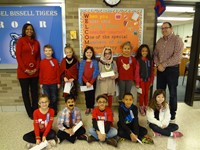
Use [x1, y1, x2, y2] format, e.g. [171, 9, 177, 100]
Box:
[16, 36, 40, 78]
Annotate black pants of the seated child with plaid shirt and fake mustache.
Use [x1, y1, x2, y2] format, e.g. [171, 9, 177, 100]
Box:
[57, 127, 85, 143]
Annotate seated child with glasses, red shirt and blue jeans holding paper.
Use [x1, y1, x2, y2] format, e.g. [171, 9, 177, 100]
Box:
[88, 95, 117, 147]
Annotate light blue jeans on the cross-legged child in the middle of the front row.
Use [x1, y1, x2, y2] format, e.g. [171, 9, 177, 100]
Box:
[89, 127, 117, 140]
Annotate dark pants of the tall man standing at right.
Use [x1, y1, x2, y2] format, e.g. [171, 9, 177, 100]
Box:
[157, 65, 179, 120]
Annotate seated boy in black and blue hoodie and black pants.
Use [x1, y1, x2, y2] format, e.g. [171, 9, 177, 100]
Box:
[117, 93, 154, 144]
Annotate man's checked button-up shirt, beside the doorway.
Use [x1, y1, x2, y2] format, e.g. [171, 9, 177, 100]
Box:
[154, 33, 184, 68]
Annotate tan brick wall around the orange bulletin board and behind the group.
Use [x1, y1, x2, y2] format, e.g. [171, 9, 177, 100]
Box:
[0, 0, 155, 108]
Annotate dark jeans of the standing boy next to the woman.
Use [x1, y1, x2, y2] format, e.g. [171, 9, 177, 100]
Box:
[42, 84, 58, 114]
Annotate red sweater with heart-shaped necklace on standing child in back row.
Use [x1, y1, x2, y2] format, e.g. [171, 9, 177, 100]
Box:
[117, 56, 136, 81]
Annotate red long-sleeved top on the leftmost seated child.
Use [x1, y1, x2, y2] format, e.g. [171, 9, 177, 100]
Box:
[33, 108, 54, 140]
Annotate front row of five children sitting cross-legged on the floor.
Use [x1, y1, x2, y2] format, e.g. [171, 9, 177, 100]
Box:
[23, 89, 183, 148]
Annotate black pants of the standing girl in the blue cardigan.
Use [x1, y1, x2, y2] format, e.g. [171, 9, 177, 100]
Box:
[84, 82, 96, 108]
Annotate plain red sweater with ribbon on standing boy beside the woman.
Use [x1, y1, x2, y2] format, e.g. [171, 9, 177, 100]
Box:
[39, 58, 60, 84]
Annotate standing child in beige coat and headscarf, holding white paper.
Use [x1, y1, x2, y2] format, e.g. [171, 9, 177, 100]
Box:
[96, 47, 118, 107]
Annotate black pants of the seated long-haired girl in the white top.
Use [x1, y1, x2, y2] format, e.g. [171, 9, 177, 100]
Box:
[149, 123, 178, 136]
